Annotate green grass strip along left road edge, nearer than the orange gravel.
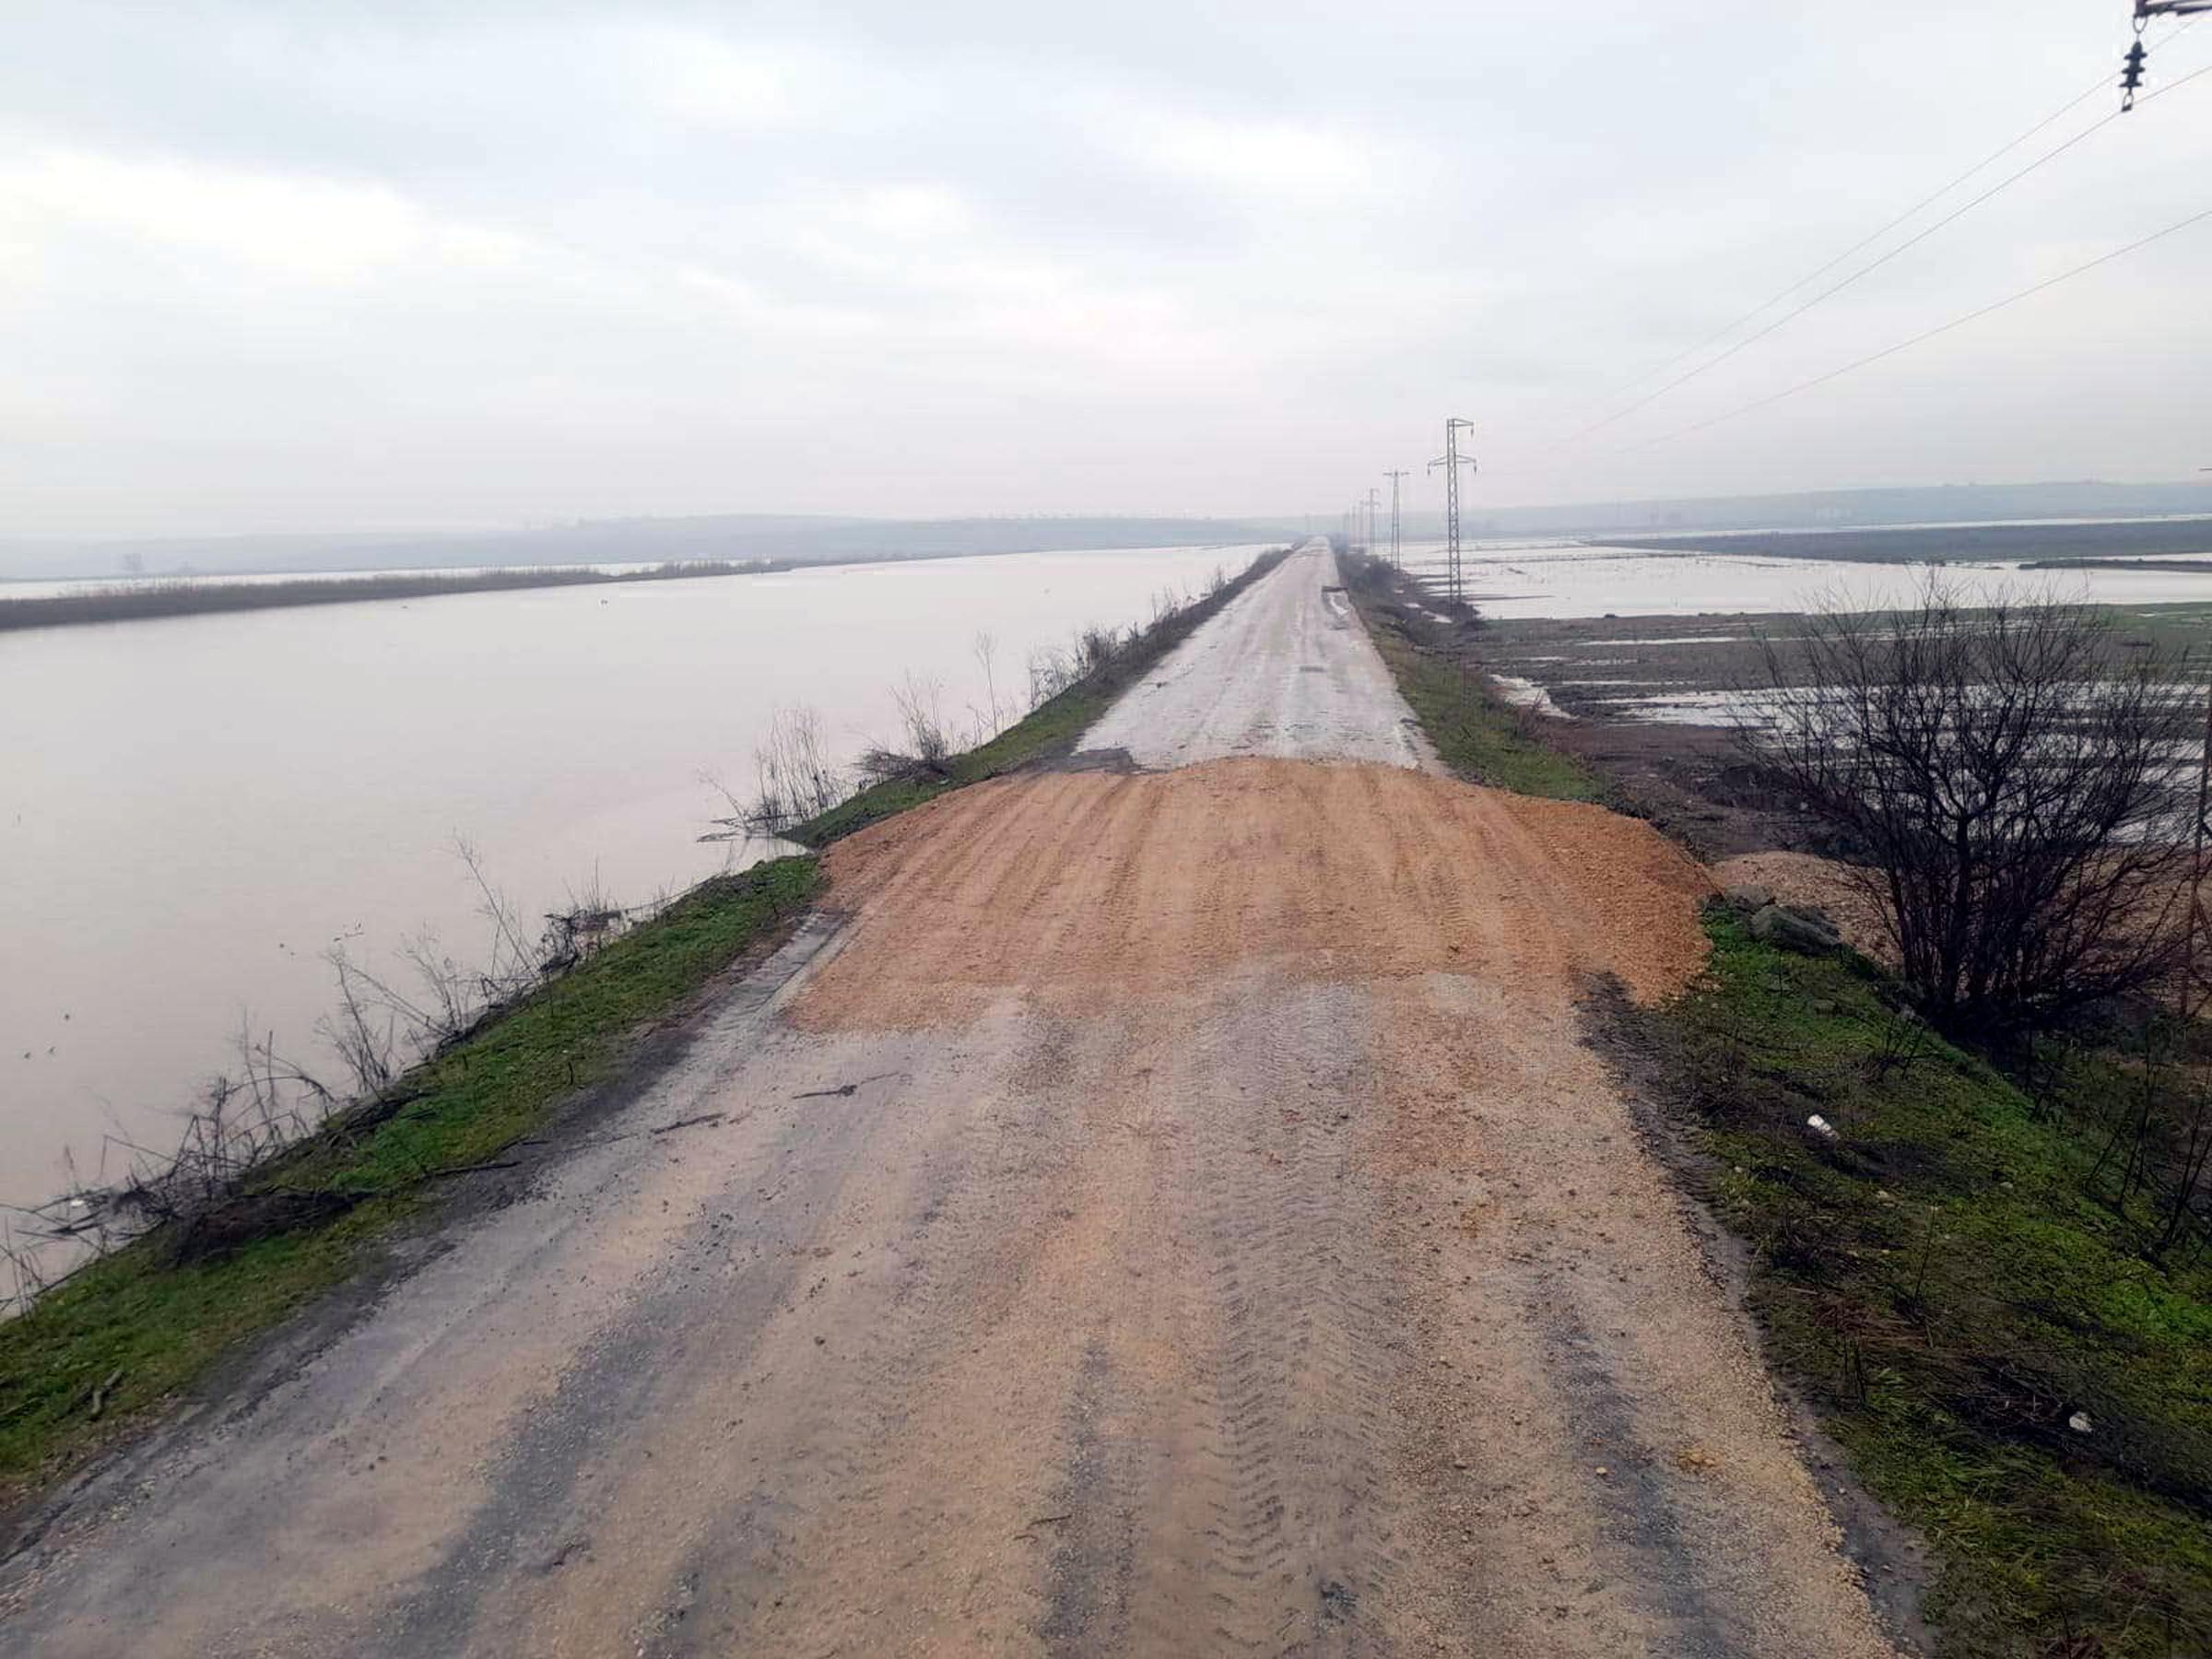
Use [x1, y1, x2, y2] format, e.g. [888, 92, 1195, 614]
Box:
[0, 858, 820, 1498]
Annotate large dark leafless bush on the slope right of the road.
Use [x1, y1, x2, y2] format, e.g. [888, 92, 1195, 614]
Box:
[1738, 582, 2196, 1030]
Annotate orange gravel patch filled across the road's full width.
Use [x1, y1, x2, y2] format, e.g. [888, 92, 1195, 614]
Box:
[794, 759, 1712, 1029]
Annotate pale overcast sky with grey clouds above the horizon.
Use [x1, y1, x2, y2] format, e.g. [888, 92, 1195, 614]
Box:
[0, 0, 2212, 535]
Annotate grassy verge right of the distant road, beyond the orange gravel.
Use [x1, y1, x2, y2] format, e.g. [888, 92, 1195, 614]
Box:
[1345, 559, 1606, 801]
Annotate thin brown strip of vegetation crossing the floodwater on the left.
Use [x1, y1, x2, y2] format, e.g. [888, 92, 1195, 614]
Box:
[0, 559, 792, 632]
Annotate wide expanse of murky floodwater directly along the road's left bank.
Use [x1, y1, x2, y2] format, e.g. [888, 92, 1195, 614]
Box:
[0, 547, 1256, 1204]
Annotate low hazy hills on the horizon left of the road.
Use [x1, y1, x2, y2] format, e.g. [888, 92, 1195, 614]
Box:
[0, 513, 1305, 577]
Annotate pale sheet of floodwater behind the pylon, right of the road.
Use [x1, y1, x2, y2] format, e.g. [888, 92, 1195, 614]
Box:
[1405, 542, 2212, 619]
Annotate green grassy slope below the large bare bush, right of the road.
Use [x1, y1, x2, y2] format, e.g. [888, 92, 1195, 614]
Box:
[1648, 916, 2212, 1659]
